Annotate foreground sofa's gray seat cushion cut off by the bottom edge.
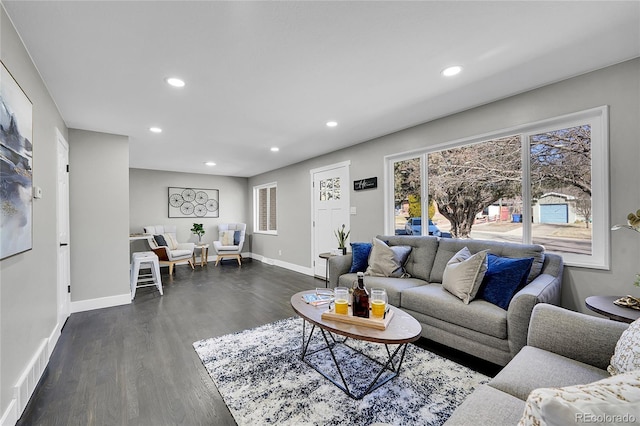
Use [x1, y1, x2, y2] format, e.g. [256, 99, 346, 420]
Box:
[444, 385, 524, 426]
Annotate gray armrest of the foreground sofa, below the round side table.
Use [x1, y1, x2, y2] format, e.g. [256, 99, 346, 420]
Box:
[527, 304, 629, 369]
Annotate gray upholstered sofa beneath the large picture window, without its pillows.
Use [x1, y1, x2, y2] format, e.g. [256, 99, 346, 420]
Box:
[329, 236, 563, 365]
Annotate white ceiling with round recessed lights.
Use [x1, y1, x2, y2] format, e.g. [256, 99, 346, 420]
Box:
[3, 0, 640, 176]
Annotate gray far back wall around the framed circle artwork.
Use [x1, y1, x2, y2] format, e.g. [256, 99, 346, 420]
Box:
[129, 169, 250, 250]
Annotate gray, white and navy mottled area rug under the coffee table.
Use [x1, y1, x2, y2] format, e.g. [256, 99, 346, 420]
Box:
[193, 317, 489, 426]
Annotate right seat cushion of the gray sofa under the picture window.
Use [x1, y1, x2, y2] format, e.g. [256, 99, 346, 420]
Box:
[400, 284, 507, 339]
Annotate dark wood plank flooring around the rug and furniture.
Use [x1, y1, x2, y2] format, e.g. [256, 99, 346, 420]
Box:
[17, 260, 498, 426]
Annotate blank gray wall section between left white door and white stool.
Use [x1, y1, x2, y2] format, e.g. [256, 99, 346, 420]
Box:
[69, 129, 130, 302]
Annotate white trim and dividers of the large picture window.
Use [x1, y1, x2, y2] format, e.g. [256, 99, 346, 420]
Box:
[384, 106, 611, 270]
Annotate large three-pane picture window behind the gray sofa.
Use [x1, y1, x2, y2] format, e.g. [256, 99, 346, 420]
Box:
[385, 107, 609, 269]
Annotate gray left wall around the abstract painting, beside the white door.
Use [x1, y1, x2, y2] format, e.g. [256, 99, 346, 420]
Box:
[0, 7, 67, 416]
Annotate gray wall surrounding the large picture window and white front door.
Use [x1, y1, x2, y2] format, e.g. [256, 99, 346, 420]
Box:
[249, 59, 640, 312]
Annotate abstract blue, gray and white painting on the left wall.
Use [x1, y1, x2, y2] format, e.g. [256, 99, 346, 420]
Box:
[0, 60, 33, 259]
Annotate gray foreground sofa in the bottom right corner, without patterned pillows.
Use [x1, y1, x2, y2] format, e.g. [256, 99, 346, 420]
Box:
[445, 304, 637, 426]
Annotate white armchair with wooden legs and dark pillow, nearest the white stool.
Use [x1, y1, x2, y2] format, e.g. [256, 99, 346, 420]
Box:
[144, 225, 196, 275]
